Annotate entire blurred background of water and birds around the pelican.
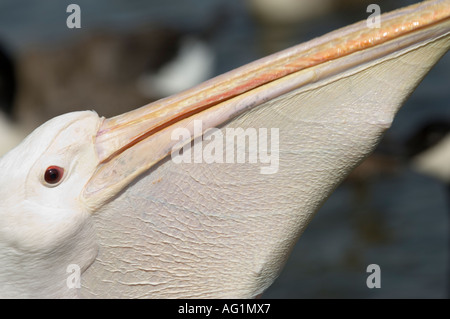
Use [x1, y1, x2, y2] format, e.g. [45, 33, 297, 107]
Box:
[0, 0, 450, 298]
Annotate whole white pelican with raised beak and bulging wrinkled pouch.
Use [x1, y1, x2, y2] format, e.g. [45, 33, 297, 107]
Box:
[0, 0, 450, 298]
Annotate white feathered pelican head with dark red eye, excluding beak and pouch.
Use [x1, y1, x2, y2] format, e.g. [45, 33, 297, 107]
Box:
[0, 112, 101, 297]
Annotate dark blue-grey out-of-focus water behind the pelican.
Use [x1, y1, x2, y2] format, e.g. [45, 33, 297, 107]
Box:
[0, 0, 450, 298]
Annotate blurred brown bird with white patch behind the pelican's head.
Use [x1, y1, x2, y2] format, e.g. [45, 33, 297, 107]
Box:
[0, 3, 229, 153]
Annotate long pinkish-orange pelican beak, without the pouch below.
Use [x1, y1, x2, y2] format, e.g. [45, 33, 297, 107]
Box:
[84, 1, 450, 209]
